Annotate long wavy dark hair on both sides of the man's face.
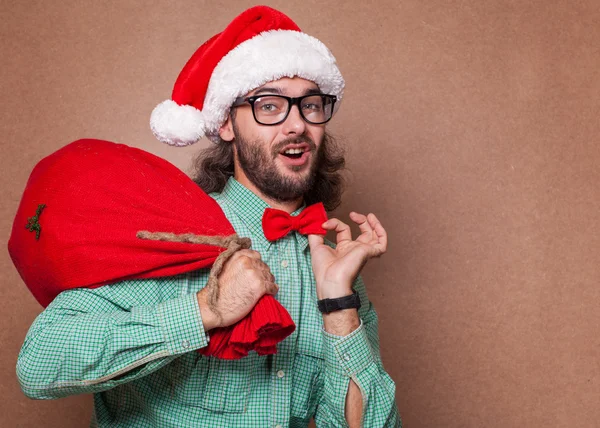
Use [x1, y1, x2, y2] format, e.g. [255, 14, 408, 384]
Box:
[192, 132, 346, 211]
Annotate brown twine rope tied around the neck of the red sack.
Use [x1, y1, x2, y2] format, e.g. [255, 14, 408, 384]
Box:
[136, 230, 252, 317]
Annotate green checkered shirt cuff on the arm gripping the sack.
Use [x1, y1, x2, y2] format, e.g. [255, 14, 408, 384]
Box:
[157, 293, 208, 355]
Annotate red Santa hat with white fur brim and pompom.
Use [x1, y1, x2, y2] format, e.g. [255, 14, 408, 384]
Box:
[150, 6, 344, 146]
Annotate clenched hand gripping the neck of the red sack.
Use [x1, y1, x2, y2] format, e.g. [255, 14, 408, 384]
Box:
[197, 250, 279, 332]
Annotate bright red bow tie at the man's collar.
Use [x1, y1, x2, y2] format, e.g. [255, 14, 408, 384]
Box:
[262, 202, 327, 241]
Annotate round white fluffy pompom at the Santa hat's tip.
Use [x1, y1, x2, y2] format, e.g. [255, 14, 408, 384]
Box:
[150, 100, 205, 146]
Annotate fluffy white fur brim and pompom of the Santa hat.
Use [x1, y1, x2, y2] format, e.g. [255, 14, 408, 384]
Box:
[150, 30, 344, 146]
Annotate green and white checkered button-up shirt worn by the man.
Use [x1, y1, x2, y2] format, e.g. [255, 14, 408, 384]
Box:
[17, 178, 401, 428]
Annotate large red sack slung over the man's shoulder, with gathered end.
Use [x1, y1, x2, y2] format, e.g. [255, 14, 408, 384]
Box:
[8, 139, 295, 359]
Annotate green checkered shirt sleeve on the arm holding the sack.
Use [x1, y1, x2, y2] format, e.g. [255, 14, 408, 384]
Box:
[17, 278, 208, 399]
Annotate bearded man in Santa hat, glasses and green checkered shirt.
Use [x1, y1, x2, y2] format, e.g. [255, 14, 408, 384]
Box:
[17, 7, 401, 427]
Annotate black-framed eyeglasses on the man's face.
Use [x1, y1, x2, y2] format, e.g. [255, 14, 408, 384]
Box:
[232, 94, 337, 126]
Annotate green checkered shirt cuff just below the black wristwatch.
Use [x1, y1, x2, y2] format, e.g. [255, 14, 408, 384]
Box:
[322, 320, 375, 377]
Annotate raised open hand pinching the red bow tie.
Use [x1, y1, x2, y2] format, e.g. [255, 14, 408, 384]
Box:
[308, 212, 387, 299]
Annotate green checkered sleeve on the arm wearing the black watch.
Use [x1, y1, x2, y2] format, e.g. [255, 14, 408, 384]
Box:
[315, 276, 402, 427]
